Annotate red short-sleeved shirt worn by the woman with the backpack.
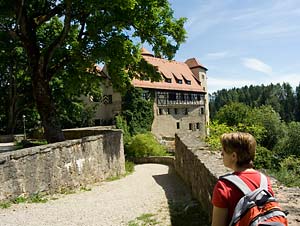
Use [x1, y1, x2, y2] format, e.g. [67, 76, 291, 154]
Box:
[212, 170, 274, 224]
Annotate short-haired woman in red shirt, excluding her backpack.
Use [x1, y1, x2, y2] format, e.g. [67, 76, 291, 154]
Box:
[212, 132, 274, 226]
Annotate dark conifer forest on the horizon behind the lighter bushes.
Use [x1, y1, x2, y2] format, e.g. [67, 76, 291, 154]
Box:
[210, 83, 300, 122]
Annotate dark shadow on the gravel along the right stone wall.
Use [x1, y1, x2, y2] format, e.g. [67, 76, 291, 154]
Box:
[153, 166, 210, 226]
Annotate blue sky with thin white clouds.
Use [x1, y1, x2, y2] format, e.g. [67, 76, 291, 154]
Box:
[169, 0, 300, 93]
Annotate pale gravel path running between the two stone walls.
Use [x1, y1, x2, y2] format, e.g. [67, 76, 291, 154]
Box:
[0, 164, 191, 226]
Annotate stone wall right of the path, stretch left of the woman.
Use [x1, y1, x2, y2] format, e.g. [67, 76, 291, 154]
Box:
[175, 134, 226, 217]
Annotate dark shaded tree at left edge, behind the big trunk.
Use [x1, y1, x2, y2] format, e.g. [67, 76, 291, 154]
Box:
[0, 31, 34, 134]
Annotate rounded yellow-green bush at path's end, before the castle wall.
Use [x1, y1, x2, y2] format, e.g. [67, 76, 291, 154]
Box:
[125, 133, 167, 157]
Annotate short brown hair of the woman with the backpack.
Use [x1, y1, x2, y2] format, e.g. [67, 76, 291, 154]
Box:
[220, 132, 256, 167]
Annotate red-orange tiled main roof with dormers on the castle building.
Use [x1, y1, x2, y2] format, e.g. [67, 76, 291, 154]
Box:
[132, 48, 205, 92]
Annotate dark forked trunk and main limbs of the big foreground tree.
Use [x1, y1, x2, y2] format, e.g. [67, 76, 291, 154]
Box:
[14, 0, 72, 143]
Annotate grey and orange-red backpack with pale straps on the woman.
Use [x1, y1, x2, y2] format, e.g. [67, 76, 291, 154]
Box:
[221, 173, 288, 226]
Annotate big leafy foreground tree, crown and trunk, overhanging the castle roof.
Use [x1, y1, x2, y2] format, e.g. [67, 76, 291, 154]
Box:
[0, 0, 185, 142]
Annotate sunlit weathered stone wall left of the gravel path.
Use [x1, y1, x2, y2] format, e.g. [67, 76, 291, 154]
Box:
[0, 129, 125, 200]
